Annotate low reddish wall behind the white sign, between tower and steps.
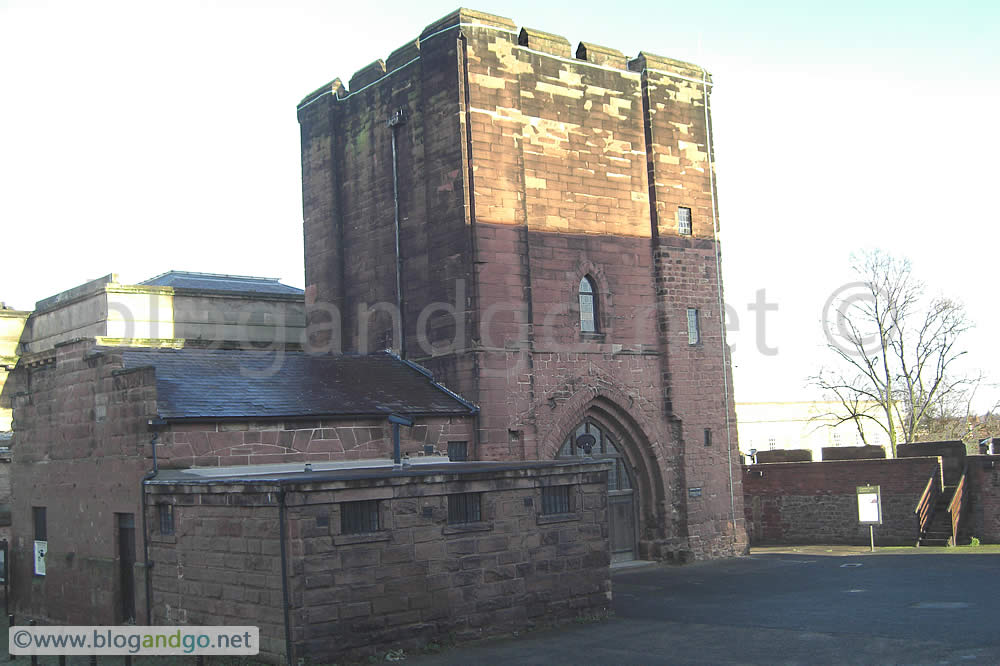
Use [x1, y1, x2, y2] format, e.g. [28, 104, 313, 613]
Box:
[743, 458, 941, 546]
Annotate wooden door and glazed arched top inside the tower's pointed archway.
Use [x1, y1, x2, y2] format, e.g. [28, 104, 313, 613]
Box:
[556, 418, 637, 562]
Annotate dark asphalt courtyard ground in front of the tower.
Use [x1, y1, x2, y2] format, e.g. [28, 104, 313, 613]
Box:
[406, 547, 1000, 666]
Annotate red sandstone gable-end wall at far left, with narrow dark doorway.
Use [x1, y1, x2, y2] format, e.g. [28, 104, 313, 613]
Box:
[11, 342, 156, 624]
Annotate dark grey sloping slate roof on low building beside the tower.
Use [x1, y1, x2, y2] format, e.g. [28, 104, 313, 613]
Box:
[118, 348, 478, 419]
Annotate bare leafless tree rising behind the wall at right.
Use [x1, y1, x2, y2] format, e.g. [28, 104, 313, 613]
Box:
[810, 250, 971, 456]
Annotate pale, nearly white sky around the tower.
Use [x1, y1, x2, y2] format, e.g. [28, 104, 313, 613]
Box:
[0, 0, 1000, 402]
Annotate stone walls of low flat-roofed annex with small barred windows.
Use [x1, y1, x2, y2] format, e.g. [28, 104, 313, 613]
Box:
[149, 463, 611, 662]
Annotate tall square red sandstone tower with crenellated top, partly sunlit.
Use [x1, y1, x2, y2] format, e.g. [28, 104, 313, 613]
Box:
[298, 9, 746, 559]
